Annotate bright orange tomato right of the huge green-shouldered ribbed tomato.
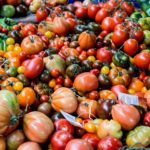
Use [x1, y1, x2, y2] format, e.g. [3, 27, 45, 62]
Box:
[17, 87, 36, 107]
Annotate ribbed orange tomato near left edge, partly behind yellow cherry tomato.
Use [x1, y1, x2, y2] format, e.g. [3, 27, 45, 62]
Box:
[1, 77, 19, 91]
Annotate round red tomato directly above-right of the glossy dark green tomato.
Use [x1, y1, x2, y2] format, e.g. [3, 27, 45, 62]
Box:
[124, 39, 139, 56]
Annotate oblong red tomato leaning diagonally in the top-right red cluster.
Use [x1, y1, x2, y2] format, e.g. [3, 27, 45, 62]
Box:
[95, 8, 109, 23]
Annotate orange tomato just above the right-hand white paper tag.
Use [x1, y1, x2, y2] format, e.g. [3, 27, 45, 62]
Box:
[129, 78, 144, 92]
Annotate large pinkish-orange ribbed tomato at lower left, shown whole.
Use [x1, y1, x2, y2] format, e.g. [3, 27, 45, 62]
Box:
[23, 111, 54, 143]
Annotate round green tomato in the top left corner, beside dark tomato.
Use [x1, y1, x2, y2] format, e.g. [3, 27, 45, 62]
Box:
[0, 5, 15, 18]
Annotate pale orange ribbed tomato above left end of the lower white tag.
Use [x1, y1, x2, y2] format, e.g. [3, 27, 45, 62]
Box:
[51, 87, 78, 113]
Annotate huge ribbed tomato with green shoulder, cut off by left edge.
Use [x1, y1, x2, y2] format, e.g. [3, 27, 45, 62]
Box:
[0, 90, 20, 135]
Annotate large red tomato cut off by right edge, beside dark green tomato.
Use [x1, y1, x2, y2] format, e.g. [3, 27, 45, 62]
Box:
[133, 51, 150, 69]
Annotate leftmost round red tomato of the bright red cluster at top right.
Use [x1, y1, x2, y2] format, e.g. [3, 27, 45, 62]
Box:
[75, 7, 87, 18]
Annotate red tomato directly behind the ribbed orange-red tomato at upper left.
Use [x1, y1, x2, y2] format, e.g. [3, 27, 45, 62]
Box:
[21, 23, 37, 36]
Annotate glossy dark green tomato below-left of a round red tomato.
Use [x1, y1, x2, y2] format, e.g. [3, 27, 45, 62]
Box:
[112, 51, 130, 67]
